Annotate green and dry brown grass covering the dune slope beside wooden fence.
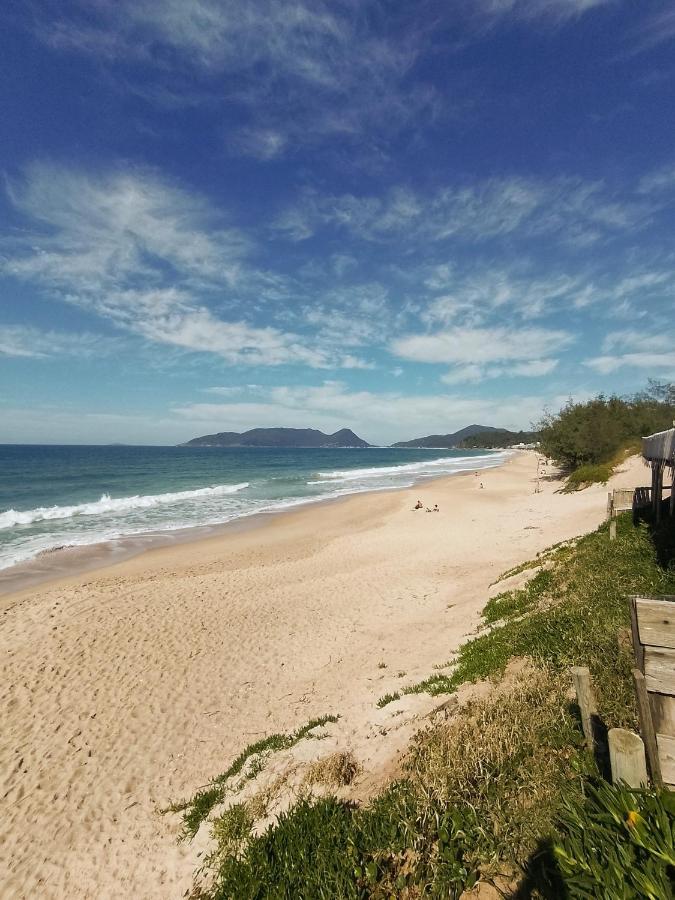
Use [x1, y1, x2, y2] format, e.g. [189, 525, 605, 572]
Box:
[186, 515, 675, 900]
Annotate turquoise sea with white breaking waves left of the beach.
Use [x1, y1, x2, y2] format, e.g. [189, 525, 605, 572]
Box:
[0, 445, 504, 569]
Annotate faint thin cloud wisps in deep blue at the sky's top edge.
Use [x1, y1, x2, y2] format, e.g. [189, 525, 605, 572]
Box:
[25, 0, 438, 160]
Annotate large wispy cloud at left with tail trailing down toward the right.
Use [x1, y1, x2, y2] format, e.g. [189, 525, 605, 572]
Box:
[0, 164, 367, 368]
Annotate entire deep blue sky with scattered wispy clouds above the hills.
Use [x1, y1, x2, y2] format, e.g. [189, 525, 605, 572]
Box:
[0, 0, 675, 444]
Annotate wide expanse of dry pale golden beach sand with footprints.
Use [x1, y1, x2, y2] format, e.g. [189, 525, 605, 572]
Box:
[0, 453, 645, 898]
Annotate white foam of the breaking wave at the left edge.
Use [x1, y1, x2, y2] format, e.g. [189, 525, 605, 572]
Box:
[0, 481, 249, 530]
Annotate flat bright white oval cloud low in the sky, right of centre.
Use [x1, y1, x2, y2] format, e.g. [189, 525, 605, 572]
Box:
[391, 327, 573, 367]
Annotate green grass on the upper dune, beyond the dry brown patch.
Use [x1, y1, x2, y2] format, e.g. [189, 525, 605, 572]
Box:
[390, 513, 675, 725]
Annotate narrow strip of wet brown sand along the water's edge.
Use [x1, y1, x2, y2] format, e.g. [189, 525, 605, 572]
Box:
[0, 448, 508, 607]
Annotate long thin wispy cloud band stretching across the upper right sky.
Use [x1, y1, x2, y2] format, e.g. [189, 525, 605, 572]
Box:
[274, 176, 652, 247]
